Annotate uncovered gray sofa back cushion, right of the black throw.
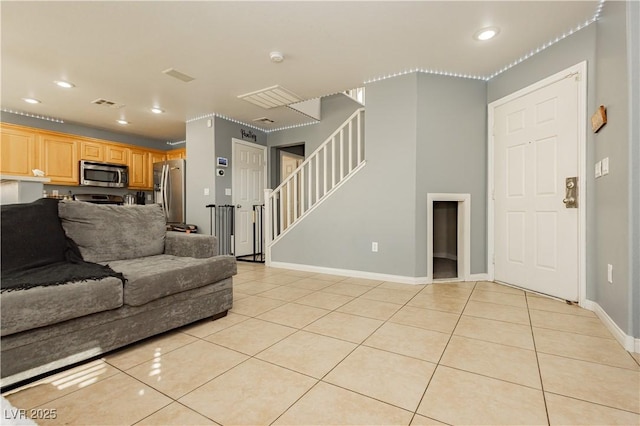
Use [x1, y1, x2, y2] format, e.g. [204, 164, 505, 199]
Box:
[58, 201, 166, 262]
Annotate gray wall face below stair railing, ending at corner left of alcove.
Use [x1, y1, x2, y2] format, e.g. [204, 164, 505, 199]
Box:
[269, 74, 417, 277]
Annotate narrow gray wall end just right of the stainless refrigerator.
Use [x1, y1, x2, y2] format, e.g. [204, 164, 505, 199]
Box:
[186, 118, 216, 234]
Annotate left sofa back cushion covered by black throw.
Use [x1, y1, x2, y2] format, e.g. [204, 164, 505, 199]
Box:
[0, 198, 67, 273]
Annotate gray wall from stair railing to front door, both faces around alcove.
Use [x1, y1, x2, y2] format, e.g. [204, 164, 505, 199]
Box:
[272, 73, 487, 277]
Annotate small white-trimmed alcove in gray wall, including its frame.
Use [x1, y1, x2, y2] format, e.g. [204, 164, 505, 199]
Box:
[427, 193, 471, 282]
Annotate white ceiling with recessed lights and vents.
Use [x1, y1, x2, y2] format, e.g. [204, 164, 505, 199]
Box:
[0, 0, 598, 141]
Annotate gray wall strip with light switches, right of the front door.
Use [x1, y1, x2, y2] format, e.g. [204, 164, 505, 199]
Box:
[590, 2, 637, 332]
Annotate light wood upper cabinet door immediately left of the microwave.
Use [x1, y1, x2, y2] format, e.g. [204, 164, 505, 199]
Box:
[38, 133, 79, 185]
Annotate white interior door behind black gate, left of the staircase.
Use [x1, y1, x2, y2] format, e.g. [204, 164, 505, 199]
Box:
[231, 139, 267, 256]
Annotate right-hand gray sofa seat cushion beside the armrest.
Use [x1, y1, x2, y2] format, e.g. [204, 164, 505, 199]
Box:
[109, 254, 236, 306]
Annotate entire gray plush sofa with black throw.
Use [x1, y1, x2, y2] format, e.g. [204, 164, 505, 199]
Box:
[0, 199, 236, 388]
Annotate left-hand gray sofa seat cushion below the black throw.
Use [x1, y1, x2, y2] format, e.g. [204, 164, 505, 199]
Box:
[0, 277, 123, 336]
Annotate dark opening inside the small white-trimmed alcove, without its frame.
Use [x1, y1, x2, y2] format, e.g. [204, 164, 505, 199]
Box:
[433, 201, 458, 280]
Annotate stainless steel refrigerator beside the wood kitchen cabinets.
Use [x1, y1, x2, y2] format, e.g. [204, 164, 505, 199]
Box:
[153, 160, 186, 223]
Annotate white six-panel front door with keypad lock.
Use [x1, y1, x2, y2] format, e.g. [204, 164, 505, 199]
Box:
[493, 75, 582, 301]
